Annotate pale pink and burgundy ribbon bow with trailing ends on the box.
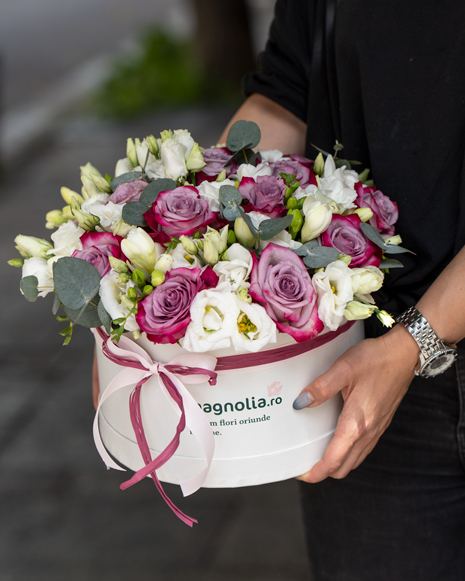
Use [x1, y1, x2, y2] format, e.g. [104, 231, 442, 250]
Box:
[93, 328, 217, 526]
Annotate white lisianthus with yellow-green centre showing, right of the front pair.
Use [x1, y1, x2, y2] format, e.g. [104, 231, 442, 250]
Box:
[232, 296, 276, 353]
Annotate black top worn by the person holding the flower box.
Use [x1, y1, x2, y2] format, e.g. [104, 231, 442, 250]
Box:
[244, 0, 465, 314]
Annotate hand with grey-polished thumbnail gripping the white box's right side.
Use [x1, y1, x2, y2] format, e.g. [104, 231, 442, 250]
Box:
[295, 325, 420, 482]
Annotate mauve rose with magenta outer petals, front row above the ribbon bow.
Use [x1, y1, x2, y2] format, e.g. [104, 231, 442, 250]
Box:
[136, 266, 218, 343]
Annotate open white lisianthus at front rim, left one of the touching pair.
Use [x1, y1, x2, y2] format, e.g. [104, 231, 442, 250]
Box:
[182, 283, 240, 353]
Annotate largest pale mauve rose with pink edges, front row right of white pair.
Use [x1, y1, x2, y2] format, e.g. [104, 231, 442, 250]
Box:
[249, 243, 324, 342]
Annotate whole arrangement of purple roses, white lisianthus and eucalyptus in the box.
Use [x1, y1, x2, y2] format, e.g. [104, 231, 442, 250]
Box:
[10, 121, 405, 352]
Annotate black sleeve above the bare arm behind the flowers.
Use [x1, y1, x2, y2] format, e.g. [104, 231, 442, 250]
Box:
[243, 0, 313, 122]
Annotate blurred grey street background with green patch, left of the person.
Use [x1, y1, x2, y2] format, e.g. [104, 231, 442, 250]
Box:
[0, 0, 309, 581]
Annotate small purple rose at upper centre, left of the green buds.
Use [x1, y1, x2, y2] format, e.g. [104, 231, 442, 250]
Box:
[238, 176, 286, 218]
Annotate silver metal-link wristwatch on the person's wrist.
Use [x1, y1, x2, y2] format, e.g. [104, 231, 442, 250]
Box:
[397, 307, 457, 377]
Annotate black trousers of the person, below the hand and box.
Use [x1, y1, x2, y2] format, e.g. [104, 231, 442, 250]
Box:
[301, 341, 465, 581]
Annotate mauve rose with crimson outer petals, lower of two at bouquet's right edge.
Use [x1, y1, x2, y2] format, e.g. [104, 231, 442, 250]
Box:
[320, 214, 383, 268]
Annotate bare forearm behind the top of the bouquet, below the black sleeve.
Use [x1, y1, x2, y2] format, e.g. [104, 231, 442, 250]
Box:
[219, 93, 307, 155]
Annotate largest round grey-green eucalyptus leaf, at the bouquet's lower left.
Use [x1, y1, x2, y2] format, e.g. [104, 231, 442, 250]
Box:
[53, 257, 100, 309]
